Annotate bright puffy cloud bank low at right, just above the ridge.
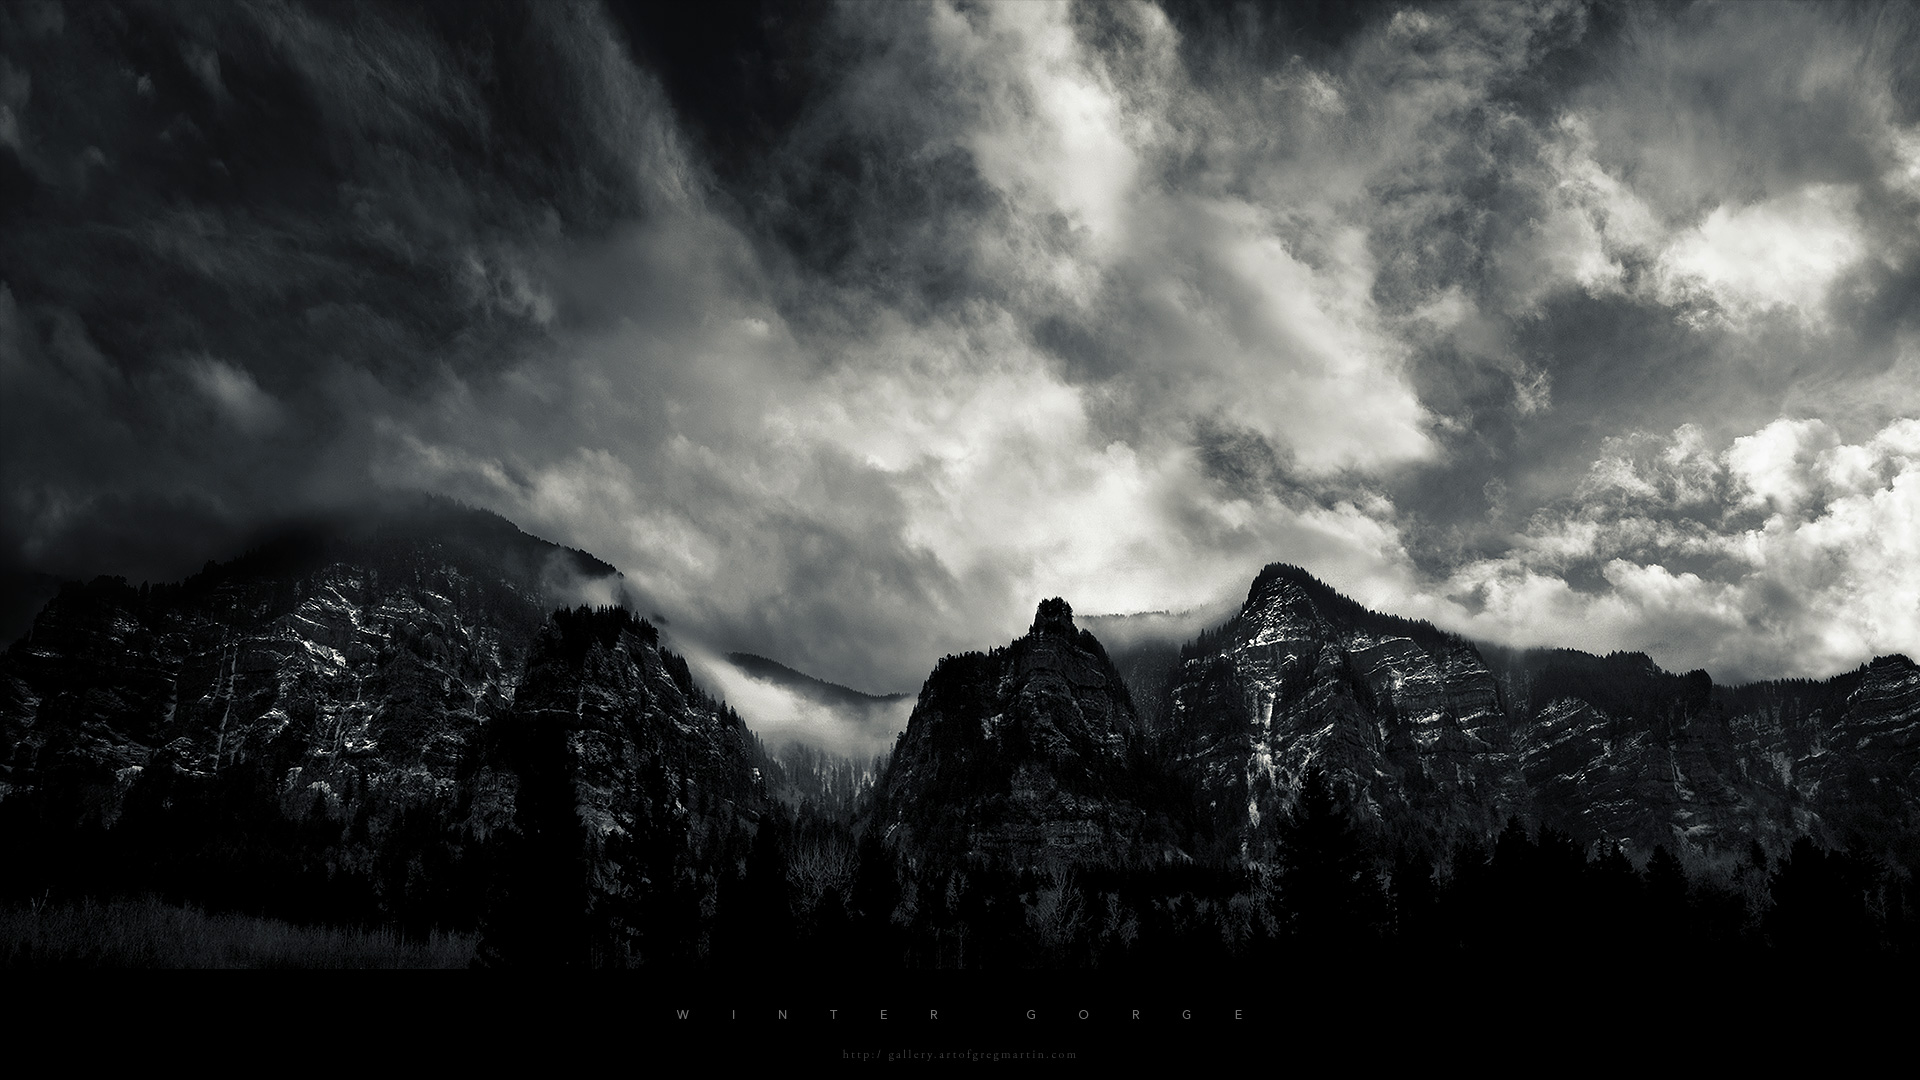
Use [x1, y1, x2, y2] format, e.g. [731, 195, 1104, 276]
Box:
[1423, 419, 1920, 678]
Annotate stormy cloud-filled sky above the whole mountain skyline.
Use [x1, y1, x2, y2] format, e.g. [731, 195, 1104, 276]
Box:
[0, 2, 1920, 690]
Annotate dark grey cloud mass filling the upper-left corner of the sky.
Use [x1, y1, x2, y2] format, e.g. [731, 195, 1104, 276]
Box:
[0, 4, 679, 622]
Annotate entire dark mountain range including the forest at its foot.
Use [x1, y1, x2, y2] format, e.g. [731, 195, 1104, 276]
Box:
[0, 500, 1920, 974]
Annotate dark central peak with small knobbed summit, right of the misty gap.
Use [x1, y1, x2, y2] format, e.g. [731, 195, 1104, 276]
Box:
[872, 598, 1167, 867]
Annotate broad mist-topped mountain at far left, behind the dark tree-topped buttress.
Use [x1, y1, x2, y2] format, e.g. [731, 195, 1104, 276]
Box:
[0, 505, 591, 821]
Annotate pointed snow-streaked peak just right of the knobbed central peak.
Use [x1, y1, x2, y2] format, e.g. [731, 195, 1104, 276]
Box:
[1164, 567, 1513, 859]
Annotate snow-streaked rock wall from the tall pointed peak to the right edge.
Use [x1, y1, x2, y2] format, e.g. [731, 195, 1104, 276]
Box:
[1154, 565, 1920, 859]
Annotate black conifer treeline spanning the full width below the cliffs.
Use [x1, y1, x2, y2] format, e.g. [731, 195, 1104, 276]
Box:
[0, 749, 1920, 974]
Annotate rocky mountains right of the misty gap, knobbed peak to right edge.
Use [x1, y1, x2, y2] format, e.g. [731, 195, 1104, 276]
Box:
[872, 565, 1920, 867]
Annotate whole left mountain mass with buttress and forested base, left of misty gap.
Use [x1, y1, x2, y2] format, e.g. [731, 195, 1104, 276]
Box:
[0, 500, 764, 963]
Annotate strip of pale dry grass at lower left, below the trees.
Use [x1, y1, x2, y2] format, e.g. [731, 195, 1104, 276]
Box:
[0, 897, 476, 969]
